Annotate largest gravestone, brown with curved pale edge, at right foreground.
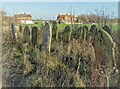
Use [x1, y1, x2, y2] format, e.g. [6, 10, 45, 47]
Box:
[92, 30, 116, 68]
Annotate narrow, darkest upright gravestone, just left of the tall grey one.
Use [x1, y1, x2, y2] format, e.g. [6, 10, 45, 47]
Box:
[32, 26, 38, 47]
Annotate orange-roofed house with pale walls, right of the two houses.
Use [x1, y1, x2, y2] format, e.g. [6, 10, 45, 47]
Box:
[57, 14, 78, 24]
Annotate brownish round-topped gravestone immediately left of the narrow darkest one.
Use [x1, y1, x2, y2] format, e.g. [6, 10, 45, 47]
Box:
[23, 26, 30, 43]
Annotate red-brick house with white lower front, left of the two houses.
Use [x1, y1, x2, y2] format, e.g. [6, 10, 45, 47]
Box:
[15, 13, 33, 24]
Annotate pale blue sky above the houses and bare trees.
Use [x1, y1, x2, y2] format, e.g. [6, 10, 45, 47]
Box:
[1, 2, 118, 19]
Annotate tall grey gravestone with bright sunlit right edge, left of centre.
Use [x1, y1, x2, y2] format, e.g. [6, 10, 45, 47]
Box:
[42, 23, 52, 53]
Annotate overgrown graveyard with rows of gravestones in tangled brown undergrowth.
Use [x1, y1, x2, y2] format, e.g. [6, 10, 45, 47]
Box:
[3, 22, 118, 87]
